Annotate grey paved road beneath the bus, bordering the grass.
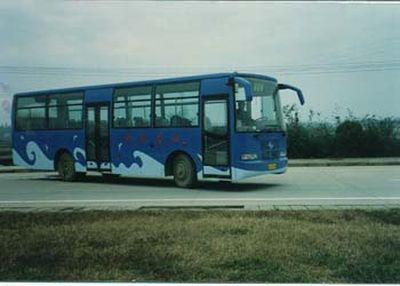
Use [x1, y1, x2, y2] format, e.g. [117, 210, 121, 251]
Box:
[0, 166, 400, 210]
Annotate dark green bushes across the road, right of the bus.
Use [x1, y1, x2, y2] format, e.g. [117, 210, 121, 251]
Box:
[283, 105, 400, 158]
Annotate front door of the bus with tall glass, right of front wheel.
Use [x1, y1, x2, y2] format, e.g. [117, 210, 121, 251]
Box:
[202, 96, 231, 178]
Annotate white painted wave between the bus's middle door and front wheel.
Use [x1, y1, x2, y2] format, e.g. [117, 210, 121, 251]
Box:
[112, 151, 164, 177]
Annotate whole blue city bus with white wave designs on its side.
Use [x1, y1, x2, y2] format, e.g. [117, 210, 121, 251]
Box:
[12, 72, 304, 187]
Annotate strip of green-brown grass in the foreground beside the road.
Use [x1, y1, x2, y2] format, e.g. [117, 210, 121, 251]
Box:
[0, 209, 400, 283]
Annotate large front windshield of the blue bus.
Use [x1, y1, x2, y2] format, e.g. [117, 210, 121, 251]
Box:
[235, 78, 284, 132]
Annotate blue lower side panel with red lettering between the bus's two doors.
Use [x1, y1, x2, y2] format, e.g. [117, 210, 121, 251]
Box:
[110, 127, 202, 177]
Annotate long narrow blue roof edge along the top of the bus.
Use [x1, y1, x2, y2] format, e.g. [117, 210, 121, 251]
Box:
[14, 72, 277, 96]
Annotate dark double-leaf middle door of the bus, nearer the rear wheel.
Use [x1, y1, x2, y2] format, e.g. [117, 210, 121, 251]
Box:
[86, 103, 111, 171]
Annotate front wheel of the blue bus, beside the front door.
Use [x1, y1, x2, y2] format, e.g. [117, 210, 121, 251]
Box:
[173, 154, 197, 188]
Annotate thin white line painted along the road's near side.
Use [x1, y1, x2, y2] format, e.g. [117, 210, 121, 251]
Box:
[0, 197, 400, 204]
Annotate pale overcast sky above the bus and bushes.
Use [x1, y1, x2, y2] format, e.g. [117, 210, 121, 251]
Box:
[0, 0, 400, 122]
